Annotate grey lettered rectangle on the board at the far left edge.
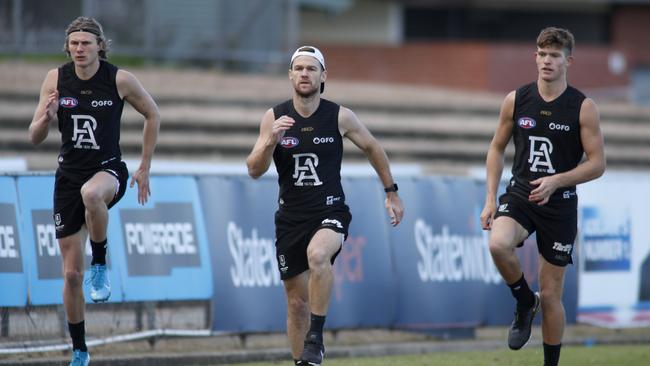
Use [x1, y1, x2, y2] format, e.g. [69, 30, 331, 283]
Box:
[0, 203, 23, 273]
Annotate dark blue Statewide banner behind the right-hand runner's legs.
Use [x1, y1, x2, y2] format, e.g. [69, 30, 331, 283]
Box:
[391, 177, 576, 330]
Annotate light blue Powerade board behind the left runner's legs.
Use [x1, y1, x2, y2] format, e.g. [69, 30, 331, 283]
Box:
[17, 176, 122, 305]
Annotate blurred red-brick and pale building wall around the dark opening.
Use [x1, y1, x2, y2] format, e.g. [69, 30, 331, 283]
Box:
[301, 0, 650, 93]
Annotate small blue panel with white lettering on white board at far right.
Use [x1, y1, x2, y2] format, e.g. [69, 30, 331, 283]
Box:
[580, 206, 632, 272]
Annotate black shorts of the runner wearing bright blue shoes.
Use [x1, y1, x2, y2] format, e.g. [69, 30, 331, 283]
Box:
[53, 161, 129, 239]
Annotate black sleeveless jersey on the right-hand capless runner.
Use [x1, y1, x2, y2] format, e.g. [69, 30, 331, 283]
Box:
[508, 82, 585, 200]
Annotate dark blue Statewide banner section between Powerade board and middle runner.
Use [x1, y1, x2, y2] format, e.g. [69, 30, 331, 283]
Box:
[198, 176, 286, 332]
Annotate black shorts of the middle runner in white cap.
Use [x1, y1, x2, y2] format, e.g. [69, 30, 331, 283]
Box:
[275, 205, 352, 280]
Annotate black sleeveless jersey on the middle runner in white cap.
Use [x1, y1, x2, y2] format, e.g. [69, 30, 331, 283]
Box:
[273, 99, 345, 212]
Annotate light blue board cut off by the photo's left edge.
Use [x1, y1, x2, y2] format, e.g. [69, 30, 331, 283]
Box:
[0, 177, 29, 306]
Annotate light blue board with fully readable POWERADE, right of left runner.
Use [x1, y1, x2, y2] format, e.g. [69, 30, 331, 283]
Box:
[114, 177, 212, 301]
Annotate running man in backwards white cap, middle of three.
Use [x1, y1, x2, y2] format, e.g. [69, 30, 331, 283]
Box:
[246, 46, 404, 366]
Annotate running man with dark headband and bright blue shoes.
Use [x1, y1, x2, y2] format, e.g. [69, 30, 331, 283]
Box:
[29, 17, 160, 366]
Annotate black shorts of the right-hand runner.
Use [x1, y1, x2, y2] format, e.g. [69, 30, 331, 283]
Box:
[494, 192, 578, 267]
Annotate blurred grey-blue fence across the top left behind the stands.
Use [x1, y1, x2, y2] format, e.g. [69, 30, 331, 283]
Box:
[0, 0, 299, 71]
